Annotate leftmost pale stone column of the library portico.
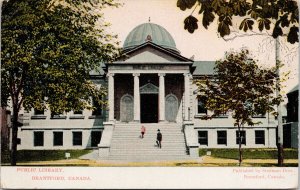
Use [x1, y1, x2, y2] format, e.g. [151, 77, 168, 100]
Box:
[108, 73, 115, 121]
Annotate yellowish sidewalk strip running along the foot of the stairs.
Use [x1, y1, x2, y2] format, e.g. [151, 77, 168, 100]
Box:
[4, 156, 298, 167]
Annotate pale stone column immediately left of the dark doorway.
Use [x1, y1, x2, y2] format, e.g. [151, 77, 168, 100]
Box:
[132, 73, 141, 122]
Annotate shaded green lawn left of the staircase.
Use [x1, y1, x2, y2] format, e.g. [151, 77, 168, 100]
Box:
[1, 150, 91, 163]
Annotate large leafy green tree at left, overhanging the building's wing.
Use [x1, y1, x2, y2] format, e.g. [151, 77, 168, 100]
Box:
[1, 0, 119, 165]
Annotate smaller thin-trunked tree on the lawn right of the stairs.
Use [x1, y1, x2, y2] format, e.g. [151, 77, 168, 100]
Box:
[194, 50, 281, 165]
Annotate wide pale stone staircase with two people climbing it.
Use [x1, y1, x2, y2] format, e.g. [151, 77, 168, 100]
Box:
[108, 123, 190, 161]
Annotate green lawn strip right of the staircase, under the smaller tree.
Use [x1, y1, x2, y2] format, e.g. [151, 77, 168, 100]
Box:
[199, 148, 298, 159]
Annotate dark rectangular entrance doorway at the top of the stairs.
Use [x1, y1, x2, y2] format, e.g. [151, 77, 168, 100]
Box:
[141, 94, 158, 123]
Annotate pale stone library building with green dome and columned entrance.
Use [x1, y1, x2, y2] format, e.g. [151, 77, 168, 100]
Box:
[14, 23, 276, 159]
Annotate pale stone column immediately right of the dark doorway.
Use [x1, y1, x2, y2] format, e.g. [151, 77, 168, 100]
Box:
[158, 73, 166, 122]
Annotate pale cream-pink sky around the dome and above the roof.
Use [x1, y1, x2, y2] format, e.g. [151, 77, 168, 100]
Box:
[104, 0, 299, 93]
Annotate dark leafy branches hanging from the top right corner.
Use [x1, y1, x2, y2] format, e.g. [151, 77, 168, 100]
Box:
[177, 0, 299, 44]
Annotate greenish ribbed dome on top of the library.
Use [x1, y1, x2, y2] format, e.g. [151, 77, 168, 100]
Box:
[123, 22, 179, 53]
